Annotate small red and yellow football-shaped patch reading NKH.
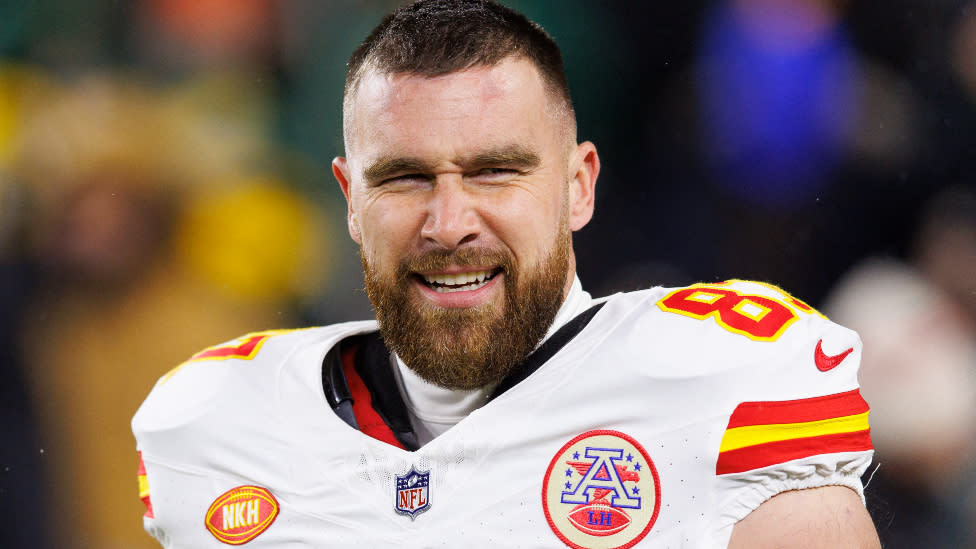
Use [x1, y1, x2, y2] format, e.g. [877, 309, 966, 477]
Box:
[206, 486, 279, 545]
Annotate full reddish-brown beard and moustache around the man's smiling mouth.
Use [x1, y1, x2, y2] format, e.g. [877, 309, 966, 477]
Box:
[362, 230, 571, 389]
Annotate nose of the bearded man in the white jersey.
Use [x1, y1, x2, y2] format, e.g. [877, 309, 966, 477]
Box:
[420, 175, 481, 249]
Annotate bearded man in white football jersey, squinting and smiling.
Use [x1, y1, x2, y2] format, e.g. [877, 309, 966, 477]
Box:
[133, 0, 879, 548]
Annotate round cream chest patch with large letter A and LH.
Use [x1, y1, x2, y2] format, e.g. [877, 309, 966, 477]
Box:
[542, 430, 661, 549]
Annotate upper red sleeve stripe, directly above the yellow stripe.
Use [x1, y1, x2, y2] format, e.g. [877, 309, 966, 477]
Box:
[728, 389, 868, 429]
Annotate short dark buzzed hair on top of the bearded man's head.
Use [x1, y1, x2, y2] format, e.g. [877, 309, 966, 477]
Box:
[343, 0, 575, 141]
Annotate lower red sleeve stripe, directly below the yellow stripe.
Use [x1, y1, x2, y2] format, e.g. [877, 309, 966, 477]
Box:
[715, 429, 874, 475]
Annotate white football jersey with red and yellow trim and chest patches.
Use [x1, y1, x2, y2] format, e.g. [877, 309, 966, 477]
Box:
[132, 281, 872, 549]
